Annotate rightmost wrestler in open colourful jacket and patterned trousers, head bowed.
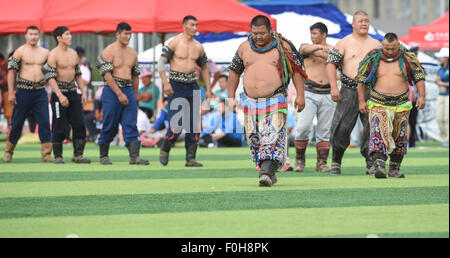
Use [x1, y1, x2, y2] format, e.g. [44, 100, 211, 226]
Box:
[356, 33, 426, 178]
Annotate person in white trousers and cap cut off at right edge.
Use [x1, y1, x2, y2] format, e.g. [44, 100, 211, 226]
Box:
[435, 48, 449, 147]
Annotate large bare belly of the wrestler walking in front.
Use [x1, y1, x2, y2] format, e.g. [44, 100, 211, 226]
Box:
[243, 64, 282, 98]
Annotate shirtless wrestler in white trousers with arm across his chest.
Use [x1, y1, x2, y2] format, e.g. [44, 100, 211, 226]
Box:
[294, 22, 334, 172]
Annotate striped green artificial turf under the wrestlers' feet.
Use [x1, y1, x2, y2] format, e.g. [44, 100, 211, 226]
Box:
[0, 143, 449, 237]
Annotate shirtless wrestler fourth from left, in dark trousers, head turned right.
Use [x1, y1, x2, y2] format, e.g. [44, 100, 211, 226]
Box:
[158, 15, 211, 167]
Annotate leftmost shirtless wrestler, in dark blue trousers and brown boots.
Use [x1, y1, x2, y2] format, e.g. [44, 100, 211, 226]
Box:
[3, 26, 53, 162]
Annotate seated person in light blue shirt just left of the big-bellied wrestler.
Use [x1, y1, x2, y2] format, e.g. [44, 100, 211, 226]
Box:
[202, 100, 244, 147]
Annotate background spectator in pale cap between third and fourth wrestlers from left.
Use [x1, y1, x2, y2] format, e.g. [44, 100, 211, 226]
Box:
[137, 70, 159, 119]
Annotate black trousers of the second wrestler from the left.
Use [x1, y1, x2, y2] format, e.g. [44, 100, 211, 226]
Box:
[50, 91, 86, 143]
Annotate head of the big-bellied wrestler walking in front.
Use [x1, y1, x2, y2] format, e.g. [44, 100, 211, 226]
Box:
[250, 15, 272, 48]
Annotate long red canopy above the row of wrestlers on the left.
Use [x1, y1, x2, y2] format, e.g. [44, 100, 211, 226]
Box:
[0, 0, 276, 34]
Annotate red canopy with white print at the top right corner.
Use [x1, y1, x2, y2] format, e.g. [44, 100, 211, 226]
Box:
[400, 12, 449, 50]
